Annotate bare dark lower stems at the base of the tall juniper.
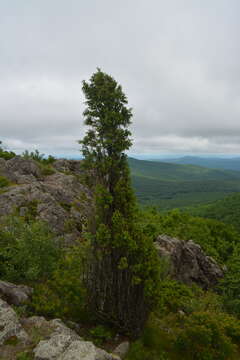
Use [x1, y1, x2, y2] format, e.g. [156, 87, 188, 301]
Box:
[87, 249, 148, 338]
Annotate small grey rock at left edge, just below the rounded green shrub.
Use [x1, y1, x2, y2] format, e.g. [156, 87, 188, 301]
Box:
[0, 281, 33, 305]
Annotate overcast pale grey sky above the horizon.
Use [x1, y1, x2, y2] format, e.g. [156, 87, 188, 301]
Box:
[0, 0, 240, 156]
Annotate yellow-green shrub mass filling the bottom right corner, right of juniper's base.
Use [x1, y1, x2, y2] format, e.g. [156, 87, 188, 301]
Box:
[127, 288, 240, 360]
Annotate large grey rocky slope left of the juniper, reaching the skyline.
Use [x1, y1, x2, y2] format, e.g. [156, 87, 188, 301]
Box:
[0, 156, 91, 240]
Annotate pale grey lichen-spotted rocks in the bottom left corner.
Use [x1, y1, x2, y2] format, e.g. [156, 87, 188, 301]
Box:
[0, 299, 121, 360]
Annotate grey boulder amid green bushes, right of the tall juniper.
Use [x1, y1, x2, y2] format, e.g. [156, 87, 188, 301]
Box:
[155, 235, 223, 289]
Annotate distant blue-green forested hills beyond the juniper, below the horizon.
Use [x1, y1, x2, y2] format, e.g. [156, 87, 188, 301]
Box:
[129, 158, 240, 210]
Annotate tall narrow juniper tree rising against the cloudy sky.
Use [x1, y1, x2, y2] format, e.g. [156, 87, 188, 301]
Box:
[79, 69, 158, 335]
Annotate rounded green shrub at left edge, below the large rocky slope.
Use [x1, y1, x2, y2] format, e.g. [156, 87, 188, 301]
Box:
[0, 216, 60, 283]
